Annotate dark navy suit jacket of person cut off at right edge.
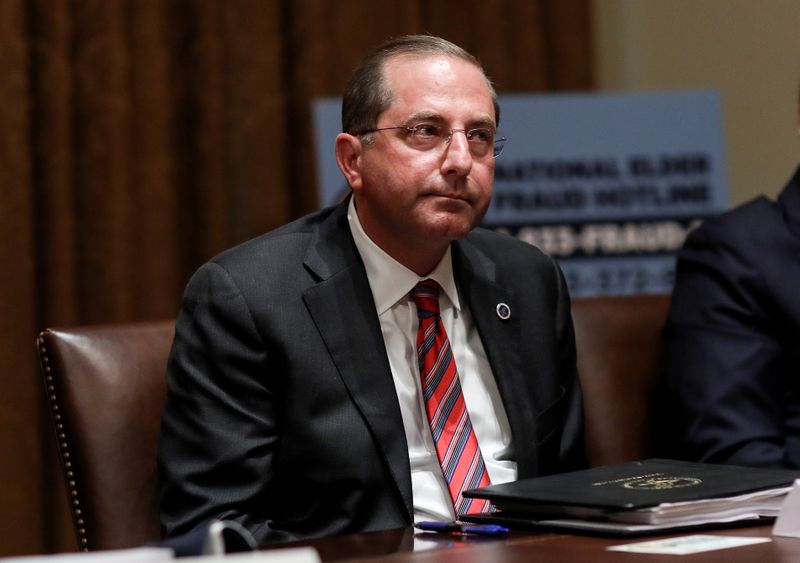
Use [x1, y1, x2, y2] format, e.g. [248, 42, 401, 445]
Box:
[662, 165, 800, 467]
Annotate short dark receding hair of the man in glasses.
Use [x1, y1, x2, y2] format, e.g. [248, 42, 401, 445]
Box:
[342, 35, 500, 134]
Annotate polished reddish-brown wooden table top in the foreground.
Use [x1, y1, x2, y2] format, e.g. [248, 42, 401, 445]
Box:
[275, 526, 800, 563]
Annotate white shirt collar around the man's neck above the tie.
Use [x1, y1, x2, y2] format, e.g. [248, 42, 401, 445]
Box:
[347, 197, 461, 316]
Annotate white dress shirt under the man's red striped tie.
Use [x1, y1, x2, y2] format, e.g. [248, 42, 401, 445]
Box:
[347, 199, 517, 521]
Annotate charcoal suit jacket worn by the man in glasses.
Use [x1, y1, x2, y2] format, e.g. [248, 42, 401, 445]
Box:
[159, 200, 583, 543]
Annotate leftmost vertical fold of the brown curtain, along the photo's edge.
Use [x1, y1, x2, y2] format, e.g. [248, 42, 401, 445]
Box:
[0, 0, 42, 549]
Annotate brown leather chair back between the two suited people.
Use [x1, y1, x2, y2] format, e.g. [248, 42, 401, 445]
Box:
[572, 295, 669, 465]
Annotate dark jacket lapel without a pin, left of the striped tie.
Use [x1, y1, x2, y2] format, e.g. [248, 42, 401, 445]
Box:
[303, 202, 413, 518]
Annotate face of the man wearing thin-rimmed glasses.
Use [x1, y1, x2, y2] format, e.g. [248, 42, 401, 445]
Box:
[344, 56, 495, 274]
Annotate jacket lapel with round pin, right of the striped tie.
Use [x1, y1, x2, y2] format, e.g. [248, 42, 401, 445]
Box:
[453, 239, 536, 475]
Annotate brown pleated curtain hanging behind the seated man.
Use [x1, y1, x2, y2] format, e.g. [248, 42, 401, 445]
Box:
[0, 0, 591, 555]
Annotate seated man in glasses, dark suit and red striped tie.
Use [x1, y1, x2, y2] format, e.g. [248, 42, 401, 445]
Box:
[159, 36, 584, 543]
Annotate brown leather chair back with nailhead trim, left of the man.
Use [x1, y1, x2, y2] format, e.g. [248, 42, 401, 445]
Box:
[37, 321, 175, 551]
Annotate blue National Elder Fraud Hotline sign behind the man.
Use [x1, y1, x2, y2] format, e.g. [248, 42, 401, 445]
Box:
[314, 91, 728, 297]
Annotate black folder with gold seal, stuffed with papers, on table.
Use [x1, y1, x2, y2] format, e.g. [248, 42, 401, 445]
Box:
[461, 459, 800, 535]
